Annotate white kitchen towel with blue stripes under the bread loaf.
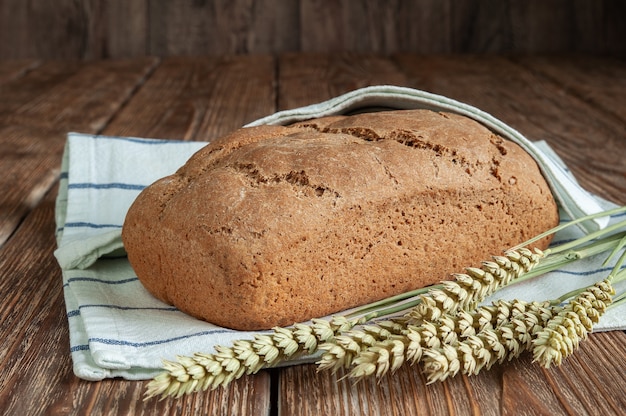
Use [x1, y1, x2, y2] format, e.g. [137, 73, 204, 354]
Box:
[55, 87, 626, 380]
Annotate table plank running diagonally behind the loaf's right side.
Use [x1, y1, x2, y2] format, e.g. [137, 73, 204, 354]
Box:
[395, 55, 626, 204]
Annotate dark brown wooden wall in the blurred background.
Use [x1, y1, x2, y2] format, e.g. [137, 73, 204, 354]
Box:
[0, 0, 626, 59]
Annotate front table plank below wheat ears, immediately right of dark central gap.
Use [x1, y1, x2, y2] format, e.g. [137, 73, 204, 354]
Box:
[278, 365, 486, 416]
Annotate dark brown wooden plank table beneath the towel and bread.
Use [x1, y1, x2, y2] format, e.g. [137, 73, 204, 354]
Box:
[0, 54, 626, 415]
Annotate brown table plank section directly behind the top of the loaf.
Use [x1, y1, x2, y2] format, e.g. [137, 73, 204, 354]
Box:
[278, 53, 410, 110]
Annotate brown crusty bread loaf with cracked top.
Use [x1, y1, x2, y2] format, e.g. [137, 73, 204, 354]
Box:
[122, 110, 558, 330]
